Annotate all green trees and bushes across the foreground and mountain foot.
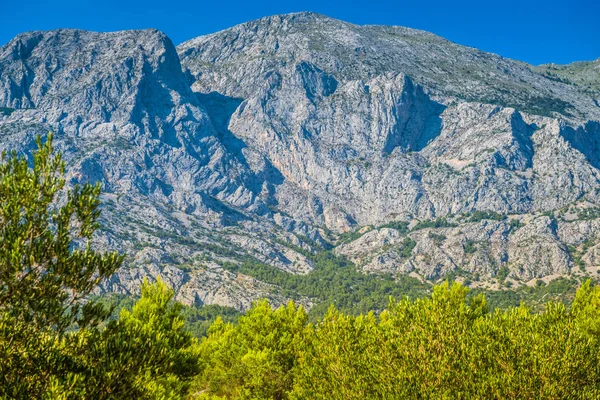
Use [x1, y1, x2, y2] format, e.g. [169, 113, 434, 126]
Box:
[0, 135, 600, 399]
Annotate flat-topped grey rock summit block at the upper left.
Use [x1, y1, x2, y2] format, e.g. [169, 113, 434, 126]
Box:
[0, 29, 189, 120]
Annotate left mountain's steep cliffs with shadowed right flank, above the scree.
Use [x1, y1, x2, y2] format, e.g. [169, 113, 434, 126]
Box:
[0, 30, 253, 208]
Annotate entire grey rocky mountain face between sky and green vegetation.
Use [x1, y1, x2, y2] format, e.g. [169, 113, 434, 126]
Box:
[0, 13, 600, 309]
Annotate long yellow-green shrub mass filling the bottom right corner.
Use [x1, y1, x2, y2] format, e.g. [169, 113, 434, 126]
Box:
[290, 284, 600, 399]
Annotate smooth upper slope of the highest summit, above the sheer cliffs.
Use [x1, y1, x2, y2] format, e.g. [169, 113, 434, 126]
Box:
[178, 13, 600, 119]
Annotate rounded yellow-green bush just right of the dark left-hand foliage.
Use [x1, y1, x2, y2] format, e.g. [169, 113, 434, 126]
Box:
[195, 301, 308, 399]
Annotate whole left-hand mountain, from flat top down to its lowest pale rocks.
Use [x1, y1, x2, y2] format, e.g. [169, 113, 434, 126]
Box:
[0, 30, 318, 307]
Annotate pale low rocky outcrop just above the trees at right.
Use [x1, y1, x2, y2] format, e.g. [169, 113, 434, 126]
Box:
[336, 216, 576, 282]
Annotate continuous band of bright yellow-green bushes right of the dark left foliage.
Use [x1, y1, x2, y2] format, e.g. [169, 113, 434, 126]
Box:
[193, 282, 600, 399]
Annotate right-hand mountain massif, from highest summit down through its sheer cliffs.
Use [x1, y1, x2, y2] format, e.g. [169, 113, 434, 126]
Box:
[178, 13, 600, 231]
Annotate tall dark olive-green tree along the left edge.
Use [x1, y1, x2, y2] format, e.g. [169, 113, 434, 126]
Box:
[0, 135, 122, 397]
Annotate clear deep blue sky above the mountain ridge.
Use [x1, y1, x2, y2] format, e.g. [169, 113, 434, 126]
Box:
[0, 0, 600, 64]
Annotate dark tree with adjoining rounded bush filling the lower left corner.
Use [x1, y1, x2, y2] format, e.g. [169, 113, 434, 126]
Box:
[0, 135, 198, 399]
